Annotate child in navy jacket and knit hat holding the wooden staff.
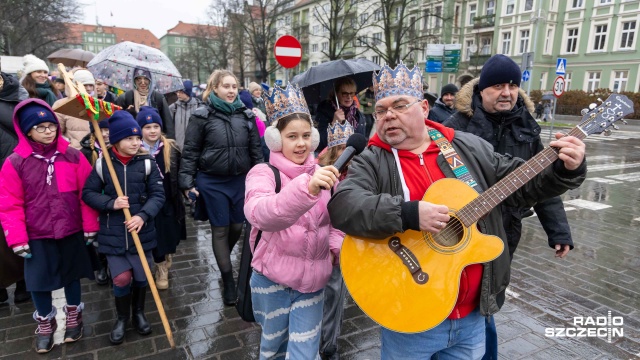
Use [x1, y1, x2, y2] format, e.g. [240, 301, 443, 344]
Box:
[82, 110, 165, 345]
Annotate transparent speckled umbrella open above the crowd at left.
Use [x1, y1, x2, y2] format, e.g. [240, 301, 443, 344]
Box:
[87, 41, 183, 94]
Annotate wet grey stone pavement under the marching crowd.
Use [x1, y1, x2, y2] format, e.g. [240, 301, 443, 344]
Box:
[0, 129, 640, 360]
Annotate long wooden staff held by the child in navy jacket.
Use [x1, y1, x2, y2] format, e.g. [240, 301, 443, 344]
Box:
[58, 64, 176, 349]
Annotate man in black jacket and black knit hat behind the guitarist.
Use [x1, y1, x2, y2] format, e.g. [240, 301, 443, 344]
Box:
[444, 55, 573, 359]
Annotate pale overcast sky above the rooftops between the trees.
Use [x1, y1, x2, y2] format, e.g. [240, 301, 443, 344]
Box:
[79, 0, 211, 39]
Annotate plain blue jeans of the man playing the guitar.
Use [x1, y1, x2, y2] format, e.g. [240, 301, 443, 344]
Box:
[382, 309, 485, 360]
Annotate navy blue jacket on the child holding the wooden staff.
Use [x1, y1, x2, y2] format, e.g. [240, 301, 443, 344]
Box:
[82, 150, 165, 255]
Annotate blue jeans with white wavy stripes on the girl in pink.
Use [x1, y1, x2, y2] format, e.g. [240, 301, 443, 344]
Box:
[251, 271, 324, 360]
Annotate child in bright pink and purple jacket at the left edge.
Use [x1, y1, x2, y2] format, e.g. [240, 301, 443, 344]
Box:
[0, 99, 99, 353]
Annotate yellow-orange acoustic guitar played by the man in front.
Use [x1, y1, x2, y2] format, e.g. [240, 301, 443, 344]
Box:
[340, 94, 633, 333]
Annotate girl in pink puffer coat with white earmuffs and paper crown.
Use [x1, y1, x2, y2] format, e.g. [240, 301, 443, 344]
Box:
[244, 86, 344, 359]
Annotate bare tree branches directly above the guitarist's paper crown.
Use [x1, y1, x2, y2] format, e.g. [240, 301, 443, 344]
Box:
[359, 0, 451, 67]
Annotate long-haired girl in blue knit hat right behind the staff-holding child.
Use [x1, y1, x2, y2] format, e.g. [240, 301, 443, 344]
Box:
[136, 106, 187, 290]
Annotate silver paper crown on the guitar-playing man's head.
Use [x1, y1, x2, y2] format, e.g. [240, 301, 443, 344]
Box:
[373, 62, 424, 101]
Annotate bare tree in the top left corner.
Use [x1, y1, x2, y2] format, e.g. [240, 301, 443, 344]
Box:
[0, 0, 82, 58]
